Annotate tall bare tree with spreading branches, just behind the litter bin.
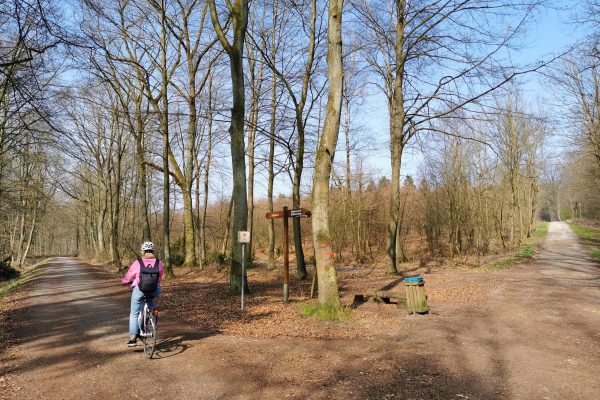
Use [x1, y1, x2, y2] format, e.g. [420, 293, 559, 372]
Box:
[352, 0, 540, 273]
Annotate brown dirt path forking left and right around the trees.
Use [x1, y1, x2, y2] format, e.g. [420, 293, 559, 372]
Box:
[0, 223, 600, 399]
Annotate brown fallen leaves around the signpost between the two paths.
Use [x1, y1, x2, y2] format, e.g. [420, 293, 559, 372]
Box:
[152, 265, 500, 339]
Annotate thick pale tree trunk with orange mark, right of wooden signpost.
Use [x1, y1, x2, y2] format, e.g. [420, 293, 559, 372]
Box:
[312, 0, 344, 308]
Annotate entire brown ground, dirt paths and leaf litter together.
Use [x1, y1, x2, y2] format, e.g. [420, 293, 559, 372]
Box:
[0, 223, 600, 399]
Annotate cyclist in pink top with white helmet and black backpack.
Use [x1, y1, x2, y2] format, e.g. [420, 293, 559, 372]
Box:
[121, 242, 165, 347]
